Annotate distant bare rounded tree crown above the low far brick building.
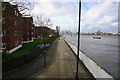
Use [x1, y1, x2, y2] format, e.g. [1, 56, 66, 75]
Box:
[35, 15, 53, 27]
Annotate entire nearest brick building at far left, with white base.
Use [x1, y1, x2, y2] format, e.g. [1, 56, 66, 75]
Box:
[0, 2, 23, 53]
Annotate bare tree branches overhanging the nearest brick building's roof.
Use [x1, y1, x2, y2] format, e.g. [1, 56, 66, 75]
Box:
[7, 0, 34, 15]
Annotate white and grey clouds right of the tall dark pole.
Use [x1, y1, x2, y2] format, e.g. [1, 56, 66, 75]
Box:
[81, 2, 118, 32]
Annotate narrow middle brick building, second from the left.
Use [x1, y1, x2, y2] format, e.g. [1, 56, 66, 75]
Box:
[23, 17, 34, 43]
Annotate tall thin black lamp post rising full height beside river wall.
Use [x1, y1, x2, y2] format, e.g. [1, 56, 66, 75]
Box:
[75, 0, 81, 80]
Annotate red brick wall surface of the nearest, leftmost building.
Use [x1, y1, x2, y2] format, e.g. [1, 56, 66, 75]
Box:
[2, 2, 22, 50]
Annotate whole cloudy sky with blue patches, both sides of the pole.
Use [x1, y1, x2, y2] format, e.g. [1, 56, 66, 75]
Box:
[6, 0, 119, 32]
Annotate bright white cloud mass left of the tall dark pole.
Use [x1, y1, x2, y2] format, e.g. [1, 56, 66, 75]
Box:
[32, 1, 78, 31]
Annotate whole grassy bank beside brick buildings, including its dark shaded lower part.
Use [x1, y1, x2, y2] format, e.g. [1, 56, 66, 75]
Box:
[2, 37, 55, 71]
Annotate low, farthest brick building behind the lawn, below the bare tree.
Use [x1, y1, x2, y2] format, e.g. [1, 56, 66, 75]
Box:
[35, 26, 55, 37]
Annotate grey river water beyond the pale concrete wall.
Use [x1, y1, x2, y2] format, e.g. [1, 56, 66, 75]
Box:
[64, 35, 120, 78]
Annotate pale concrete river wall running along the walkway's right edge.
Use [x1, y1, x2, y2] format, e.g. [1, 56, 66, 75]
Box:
[64, 38, 114, 80]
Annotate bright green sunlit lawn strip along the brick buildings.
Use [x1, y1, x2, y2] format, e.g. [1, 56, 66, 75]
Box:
[2, 38, 53, 59]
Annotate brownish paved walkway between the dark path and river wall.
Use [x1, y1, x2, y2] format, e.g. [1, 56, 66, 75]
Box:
[30, 37, 94, 80]
